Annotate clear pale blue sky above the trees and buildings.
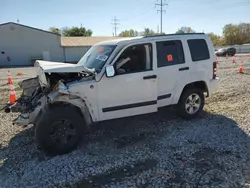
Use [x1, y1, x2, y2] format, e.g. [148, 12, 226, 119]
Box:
[0, 0, 250, 36]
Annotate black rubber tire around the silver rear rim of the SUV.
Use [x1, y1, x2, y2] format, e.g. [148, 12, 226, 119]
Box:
[178, 88, 205, 120]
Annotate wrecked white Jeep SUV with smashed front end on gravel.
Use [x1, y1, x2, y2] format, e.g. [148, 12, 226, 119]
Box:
[5, 33, 218, 154]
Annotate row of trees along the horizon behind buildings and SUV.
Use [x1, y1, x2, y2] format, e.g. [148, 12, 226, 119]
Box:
[49, 23, 250, 46]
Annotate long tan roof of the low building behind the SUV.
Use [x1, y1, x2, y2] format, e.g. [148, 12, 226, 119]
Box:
[61, 37, 124, 47]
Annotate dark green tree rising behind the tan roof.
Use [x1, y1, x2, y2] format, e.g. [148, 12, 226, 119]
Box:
[62, 27, 93, 37]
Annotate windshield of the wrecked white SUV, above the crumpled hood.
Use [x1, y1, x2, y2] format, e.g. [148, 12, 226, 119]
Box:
[77, 45, 116, 73]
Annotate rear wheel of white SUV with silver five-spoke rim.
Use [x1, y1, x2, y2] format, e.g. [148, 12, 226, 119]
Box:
[178, 89, 205, 119]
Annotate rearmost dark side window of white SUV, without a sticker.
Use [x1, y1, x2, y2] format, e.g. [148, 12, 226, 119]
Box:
[188, 39, 210, 61]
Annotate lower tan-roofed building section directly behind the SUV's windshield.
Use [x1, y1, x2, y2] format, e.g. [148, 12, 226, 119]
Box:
[61, 37, 121, 62]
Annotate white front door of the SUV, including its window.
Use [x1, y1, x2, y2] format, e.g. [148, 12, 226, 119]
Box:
[98, 44, 157, 120]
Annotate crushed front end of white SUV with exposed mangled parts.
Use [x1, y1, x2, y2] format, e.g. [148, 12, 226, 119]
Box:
[5, 61, 93, 126]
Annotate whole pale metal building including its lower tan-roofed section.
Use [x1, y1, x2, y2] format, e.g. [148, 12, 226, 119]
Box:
[0, 22, 123, 67]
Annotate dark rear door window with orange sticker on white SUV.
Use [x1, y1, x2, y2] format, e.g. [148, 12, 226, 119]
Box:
[156, 40, 185, 67]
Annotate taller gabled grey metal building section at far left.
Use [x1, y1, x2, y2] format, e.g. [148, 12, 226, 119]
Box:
[0, 22, 64, 67]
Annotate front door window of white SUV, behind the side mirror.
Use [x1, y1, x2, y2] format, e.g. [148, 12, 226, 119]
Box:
[114, 44, 152, 75]
